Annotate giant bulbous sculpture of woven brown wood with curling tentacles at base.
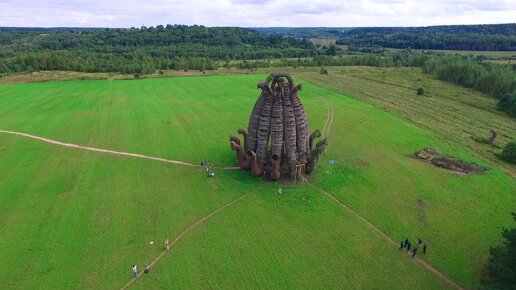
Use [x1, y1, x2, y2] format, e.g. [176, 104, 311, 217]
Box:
[229, 72, 326, 182]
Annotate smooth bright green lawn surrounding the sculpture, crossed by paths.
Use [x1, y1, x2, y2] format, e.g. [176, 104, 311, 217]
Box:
[0, 75, 516, 289]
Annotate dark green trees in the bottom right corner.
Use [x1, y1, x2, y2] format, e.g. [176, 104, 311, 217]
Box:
[480, 213, 516, 290]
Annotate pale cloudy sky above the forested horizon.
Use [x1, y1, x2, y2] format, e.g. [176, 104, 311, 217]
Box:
[0, 0, 516, 27]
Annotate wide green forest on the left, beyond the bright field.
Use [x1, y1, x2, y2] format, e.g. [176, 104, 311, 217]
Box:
[0, 25, 320, 73]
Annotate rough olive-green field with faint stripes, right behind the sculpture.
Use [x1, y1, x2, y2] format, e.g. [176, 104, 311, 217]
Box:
[298, 67, 516, 178]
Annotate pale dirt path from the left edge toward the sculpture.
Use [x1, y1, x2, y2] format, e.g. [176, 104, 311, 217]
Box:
[0, 130, 239, 170]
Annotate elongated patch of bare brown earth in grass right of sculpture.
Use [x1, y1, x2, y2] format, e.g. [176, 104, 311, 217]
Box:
[416, 148, 488, 174]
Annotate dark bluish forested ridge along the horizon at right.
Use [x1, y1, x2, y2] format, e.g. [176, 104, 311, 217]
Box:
[337, 24, 516, 51]
